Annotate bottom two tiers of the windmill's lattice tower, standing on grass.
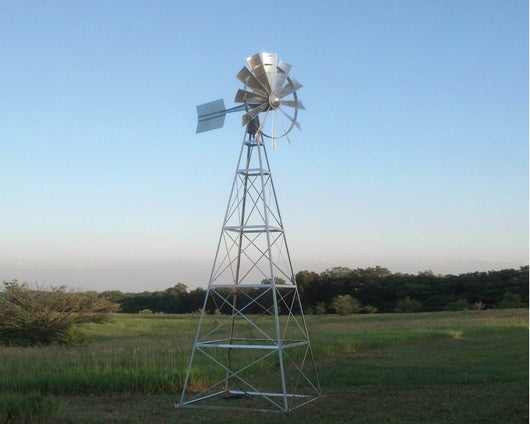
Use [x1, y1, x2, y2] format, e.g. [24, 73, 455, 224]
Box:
[186, 287, 320, 411]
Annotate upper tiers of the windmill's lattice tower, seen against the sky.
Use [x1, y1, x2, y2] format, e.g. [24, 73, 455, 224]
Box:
[211, 144, 294, 284]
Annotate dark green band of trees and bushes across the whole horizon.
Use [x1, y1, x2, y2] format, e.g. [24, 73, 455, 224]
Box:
[0, 266, 528, 346]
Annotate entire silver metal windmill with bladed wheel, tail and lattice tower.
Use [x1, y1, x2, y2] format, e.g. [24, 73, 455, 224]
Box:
[178, 53, 322, 412]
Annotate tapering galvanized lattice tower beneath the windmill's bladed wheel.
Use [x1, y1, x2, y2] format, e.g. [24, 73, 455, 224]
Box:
[180, 139, 321, 411]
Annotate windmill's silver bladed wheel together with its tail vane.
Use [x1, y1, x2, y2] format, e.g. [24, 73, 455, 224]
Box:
[197, 52, 305, 148]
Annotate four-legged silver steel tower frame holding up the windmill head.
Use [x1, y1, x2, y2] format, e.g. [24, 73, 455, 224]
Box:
[178, 129, 322, 412]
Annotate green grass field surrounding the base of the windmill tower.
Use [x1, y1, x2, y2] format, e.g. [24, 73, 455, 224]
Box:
[0, 309, 528, 424]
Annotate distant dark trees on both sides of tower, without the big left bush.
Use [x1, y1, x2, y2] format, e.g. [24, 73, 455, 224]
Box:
[101, 266, 528, 314]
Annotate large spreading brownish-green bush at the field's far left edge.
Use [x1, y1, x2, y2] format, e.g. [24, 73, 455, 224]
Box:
[0, 280, 118, 346]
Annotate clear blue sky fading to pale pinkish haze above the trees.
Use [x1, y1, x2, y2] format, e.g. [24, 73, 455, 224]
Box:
[0, 0, 529, 291]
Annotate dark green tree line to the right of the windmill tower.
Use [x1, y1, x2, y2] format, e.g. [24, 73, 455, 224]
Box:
[296, 266, 528, 312]
